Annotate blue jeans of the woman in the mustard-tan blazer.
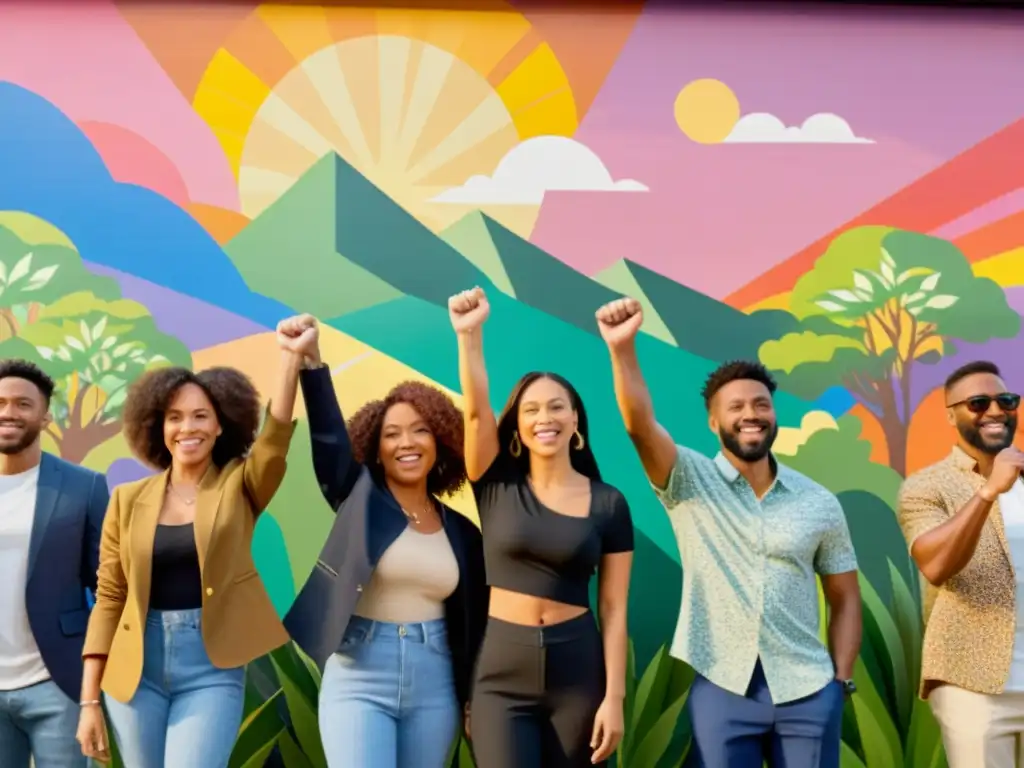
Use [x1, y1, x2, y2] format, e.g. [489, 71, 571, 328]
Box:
[104, 608, 245, 768]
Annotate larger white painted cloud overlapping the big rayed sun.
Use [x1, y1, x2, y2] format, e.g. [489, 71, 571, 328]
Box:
[430, 136, 647, 205]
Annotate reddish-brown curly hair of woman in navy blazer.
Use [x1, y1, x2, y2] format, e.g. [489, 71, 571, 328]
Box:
[348, 381, 466, 496]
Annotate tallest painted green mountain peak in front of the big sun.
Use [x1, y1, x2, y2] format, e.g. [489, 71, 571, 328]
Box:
[224, 153, 489, 317]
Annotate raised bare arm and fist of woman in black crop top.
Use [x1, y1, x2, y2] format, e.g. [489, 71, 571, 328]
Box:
[449, 288, 499, 482]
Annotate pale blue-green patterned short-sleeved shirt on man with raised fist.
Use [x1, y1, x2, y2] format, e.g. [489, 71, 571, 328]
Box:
[654, 445, 857, 705]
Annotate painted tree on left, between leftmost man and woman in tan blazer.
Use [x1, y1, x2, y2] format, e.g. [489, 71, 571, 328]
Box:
[20, 291, 191, 462]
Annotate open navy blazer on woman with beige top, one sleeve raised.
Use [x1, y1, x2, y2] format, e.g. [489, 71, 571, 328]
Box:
[285, 367, 489, 707]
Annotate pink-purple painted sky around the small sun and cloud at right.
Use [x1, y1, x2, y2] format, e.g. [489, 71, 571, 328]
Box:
[531, 6, 1024, 298]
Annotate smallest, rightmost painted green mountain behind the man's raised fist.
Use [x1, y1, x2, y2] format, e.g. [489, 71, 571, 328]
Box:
[599, 259, 798, 362]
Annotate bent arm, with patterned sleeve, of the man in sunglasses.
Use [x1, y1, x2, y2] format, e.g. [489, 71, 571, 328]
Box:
[897, 446, 1024, 587]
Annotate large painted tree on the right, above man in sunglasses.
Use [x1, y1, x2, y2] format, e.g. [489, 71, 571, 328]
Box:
[759, 226, 1021, 475]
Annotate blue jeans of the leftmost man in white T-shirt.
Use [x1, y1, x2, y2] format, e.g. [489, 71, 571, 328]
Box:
[0, 680, 86, 768]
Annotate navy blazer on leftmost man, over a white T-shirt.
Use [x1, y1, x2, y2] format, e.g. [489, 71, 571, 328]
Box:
[25, 453, 110, 701]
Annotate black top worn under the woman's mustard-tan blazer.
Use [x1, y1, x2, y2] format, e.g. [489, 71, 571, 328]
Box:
[150, 522, 203, 610]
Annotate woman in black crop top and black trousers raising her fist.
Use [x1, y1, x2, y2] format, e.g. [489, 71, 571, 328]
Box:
[449, 288, 633, 768]
